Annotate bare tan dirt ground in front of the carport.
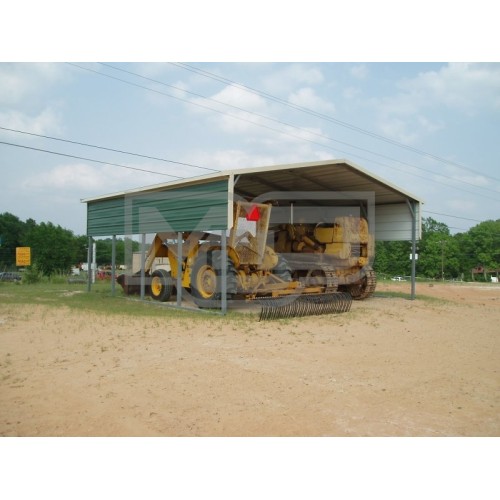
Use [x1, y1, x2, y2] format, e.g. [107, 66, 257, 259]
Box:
[0, 283, 500, 436]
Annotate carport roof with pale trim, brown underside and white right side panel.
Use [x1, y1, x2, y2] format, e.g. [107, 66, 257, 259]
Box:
[82, 159, 422, 240]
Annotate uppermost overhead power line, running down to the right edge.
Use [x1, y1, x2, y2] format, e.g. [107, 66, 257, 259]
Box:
[169, 62, 500, 182]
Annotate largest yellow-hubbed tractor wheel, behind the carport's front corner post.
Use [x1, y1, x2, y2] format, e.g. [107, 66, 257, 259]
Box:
[191, 250, 236, 309]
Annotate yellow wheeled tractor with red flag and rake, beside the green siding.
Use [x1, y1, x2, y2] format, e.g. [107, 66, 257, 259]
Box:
[118, 197, 352, 319]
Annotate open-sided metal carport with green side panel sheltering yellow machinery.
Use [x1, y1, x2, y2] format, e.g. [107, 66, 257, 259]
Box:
[82, 160, 422, 306]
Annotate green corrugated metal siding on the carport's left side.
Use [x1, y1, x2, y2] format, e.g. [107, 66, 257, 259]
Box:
[87, 180, 228, 236]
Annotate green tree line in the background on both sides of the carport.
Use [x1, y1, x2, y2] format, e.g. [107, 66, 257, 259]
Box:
[0, 212, 500, 280]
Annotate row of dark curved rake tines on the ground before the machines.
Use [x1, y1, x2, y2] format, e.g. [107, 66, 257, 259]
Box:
[255, 292, 352, 321]
